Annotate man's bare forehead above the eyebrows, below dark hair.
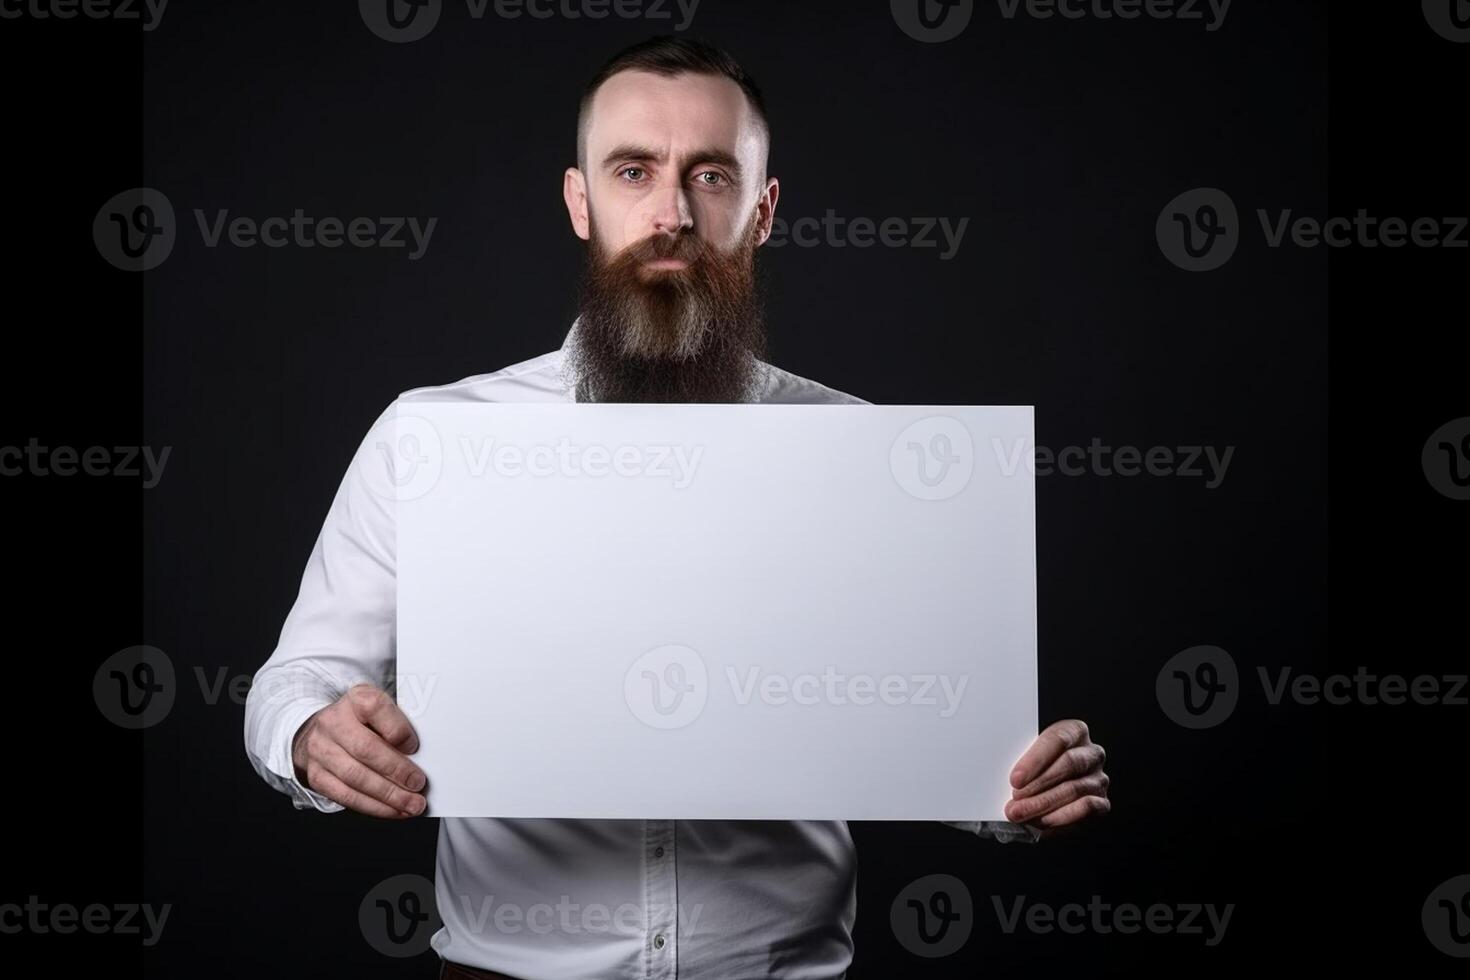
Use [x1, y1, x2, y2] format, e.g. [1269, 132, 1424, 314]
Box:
[587, 71, 763, 169]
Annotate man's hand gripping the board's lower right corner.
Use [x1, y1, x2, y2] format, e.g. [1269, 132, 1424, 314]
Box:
[1005, 718, 1113, 839]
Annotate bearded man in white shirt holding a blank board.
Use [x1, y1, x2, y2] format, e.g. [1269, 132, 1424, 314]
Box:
[245, 38, 1108, 980]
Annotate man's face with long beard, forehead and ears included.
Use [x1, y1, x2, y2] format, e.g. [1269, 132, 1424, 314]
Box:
[567, 72, 776, 401]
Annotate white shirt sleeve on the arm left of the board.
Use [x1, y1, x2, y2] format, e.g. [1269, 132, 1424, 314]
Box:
[244, 403, 397, 813]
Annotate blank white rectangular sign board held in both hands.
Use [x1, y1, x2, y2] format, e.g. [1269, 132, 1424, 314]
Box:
[391, 401, 1036, 820]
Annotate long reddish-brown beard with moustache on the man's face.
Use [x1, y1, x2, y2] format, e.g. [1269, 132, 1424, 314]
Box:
[567, 216, 766, 403]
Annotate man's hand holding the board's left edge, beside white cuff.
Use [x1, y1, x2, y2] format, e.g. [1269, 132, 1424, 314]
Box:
[291, 685, 428, 820]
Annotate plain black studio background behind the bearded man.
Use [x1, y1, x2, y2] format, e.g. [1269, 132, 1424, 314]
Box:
[0, 0, 1470, 980]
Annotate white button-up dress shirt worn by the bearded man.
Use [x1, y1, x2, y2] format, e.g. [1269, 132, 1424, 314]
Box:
[245, 322, 1035, 980]
